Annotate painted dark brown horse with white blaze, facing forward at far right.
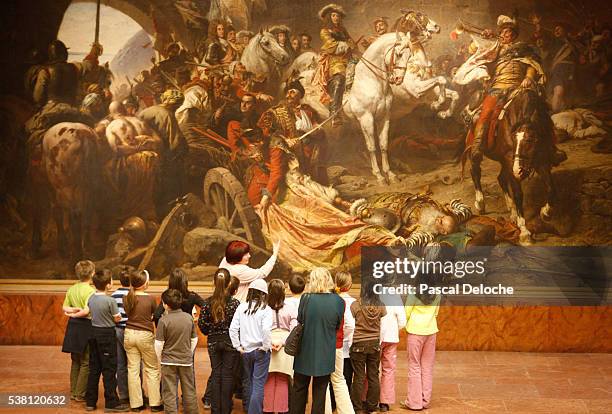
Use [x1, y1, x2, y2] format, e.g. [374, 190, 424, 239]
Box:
[463, 89, 556, 244]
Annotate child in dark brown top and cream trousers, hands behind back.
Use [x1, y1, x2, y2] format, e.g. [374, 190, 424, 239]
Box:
[124, 270, 164, 412]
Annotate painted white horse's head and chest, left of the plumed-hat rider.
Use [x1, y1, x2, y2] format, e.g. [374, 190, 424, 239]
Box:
[240, 30, 290, 96]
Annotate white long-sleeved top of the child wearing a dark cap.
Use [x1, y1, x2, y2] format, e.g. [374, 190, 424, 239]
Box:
[229, 303, 274, 352]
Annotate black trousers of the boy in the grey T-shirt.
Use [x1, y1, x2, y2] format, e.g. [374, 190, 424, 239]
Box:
[85, 327, 119, 408]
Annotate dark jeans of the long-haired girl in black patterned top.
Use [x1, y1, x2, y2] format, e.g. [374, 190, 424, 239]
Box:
[207, 335, 240, 414]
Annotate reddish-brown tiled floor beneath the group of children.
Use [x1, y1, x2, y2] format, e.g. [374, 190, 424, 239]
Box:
[0, 346, 612, 414]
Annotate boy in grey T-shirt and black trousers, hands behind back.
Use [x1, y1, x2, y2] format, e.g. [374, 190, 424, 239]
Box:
[85, 269, 128, 413]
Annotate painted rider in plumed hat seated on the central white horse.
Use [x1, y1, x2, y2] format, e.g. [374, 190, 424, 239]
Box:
[313, 3, 356, 126]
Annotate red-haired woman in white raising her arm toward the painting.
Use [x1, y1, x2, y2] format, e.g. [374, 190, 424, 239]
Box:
[219, 240, 280, 303]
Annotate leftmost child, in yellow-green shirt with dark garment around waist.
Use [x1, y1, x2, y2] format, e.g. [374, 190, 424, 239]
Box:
[62, 260, 96, 402]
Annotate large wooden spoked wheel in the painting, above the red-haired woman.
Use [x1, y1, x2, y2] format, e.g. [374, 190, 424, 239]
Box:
[204, 167, 266, 248]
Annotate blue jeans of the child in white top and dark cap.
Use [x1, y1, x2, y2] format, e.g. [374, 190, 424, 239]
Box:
[242, 349, 272, 414]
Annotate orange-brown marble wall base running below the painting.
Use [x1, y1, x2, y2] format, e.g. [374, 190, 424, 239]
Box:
[0, 287, 612, 352]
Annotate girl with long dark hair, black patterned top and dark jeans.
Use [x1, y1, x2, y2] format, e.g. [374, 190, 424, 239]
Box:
[198, 269, 240, 414]
